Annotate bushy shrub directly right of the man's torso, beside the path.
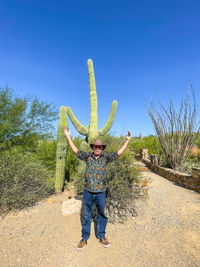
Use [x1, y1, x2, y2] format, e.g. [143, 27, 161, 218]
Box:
[106, 151, 140, 222]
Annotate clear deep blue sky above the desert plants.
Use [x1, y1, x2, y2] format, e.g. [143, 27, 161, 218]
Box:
[0, 0, 200, 136]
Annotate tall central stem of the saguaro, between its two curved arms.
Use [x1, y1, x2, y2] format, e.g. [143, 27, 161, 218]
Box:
[87, 59, 98, 132]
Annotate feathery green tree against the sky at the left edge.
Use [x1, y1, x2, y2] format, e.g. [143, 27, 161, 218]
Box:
[0, 87, 58, 151]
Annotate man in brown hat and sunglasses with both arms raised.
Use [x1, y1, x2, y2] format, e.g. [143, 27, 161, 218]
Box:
[64, 127, 131, 250]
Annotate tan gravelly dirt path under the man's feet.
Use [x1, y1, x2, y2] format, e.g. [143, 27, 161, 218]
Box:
[0, 165, 200, 267]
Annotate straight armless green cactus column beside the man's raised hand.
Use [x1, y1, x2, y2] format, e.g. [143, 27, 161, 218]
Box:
[55, 106, 68, 193]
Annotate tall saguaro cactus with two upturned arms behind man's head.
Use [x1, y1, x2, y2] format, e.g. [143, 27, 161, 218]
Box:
[67, 59, 117, 143]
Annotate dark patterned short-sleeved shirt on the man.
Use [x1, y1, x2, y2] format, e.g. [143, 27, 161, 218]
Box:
[77, 150, 118, 193]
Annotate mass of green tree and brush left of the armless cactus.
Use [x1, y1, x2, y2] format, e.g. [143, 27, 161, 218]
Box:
[0, 88, 57, 216]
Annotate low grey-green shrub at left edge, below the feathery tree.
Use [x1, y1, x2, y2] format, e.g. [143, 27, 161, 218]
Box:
[0, 149, 54, 215]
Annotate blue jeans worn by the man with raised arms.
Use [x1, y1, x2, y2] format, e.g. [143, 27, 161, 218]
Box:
[82, 190, 108, 240]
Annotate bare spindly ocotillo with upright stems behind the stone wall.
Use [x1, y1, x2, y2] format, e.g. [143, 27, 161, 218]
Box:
[147, 87, 200, 169]
